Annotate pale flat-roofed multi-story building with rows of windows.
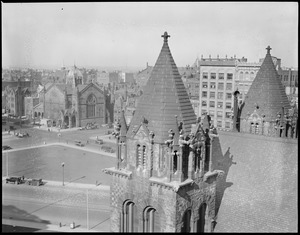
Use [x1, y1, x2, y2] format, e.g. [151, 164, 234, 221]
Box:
[198, 57, 247, 129]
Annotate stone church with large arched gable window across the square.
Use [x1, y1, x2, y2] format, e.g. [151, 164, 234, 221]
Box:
[27, 66, 109, 128]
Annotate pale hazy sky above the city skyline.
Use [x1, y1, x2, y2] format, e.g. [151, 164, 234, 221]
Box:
[1, 2, 298, 68]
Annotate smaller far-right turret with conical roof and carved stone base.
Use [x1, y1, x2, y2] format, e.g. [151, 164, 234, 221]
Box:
[234, 46, 298, 138]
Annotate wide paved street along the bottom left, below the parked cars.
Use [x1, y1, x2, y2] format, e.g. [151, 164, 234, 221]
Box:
[2, 180, 110, 231]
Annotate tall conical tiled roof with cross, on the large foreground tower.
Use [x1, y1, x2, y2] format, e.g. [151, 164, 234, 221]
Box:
[127, 32, 196, 143]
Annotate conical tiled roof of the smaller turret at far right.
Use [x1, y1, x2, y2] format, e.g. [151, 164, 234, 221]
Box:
[241, 46, 291, 121]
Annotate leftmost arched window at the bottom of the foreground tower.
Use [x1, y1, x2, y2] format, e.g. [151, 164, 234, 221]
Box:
[121, 200, 134, 232]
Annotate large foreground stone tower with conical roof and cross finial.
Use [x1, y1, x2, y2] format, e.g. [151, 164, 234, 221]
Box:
[104, 32, 223, 232]
